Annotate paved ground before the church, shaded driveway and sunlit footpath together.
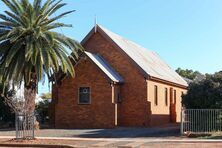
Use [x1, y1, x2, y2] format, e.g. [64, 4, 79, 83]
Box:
[0, 126, 222, 148]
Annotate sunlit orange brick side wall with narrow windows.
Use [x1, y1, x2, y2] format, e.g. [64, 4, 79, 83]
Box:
[147, 80, 186, 126]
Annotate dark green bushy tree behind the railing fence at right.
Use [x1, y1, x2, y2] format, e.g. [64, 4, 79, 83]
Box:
[182, 72, 222, 109]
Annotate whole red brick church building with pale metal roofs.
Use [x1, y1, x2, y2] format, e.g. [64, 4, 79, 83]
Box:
[52, 25, 187, 128]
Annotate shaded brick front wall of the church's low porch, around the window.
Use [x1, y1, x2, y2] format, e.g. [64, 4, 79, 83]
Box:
[55, 58, 115, 128]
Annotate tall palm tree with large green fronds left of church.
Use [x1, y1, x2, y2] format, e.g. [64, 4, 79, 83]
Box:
[0, 0, 83, 113]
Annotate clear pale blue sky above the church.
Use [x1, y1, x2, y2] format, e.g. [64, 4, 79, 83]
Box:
[0, 0, 222, 93]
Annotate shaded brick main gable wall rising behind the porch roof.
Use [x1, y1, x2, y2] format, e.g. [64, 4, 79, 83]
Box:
[84, 33, 150, 126]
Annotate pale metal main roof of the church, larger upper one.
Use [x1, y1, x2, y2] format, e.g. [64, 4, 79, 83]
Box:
[81, 25, 188, 87]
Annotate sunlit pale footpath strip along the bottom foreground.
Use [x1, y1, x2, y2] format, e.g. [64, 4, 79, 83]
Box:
[0, 136, 222, 148]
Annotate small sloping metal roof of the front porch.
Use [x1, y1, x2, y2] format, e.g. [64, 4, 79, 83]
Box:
[85, 51, 124, 83]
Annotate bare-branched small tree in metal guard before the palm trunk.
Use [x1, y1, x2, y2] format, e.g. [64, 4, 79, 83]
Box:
[1, 84, 35, 139]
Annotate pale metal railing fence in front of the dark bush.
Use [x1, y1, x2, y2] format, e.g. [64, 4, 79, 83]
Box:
[181, 109, 222, 134]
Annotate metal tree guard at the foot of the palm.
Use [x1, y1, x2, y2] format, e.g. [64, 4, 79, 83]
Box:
[15, 114, 35, 139]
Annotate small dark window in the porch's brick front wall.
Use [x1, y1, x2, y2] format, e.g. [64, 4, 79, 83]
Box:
[79, 87, 91, 104]
